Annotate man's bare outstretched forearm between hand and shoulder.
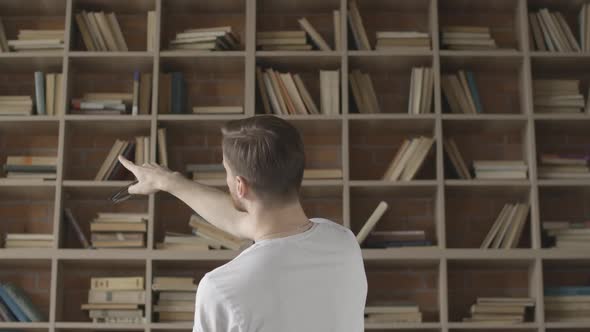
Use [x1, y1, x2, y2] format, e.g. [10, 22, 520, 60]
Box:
[160, 172, 246, 238]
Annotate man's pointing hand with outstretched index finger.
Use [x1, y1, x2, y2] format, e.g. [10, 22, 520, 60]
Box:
[119, 155, 182, 195]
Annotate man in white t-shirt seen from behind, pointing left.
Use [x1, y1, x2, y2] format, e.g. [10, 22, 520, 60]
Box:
[119, 115, 367, 332]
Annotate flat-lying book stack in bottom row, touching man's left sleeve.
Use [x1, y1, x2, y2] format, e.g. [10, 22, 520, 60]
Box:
[152, 277, 197, 323]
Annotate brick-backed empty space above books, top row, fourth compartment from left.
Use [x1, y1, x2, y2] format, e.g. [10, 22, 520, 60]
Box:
[256, 0, 346, 50]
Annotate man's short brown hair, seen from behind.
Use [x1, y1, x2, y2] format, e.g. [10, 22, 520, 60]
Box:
[221, 115, 305, 203]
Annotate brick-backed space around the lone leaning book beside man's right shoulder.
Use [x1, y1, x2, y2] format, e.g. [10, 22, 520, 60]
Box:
[350, 186, 439, 249]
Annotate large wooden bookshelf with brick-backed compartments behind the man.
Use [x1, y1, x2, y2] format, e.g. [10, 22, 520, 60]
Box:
[0, 0, 590, 332]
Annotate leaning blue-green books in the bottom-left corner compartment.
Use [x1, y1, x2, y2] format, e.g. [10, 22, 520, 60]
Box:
[0, 283, 47, 322]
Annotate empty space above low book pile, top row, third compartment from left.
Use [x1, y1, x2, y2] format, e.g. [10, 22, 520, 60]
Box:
[160, 0, 246, 53]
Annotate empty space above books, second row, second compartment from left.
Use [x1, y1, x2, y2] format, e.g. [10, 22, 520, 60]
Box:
[66, 55, 153, 116]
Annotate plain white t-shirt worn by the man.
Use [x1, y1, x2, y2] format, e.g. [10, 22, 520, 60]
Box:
[193, 218, 367, 332]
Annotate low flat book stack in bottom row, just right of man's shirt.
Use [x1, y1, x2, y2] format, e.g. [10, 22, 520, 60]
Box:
[365, 302, 422, 323]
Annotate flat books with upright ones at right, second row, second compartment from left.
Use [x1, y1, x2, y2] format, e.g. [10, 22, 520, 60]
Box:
[70, 71, 152, 115]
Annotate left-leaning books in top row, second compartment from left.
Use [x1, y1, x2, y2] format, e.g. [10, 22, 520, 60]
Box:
[75, 10, 129, 52]
